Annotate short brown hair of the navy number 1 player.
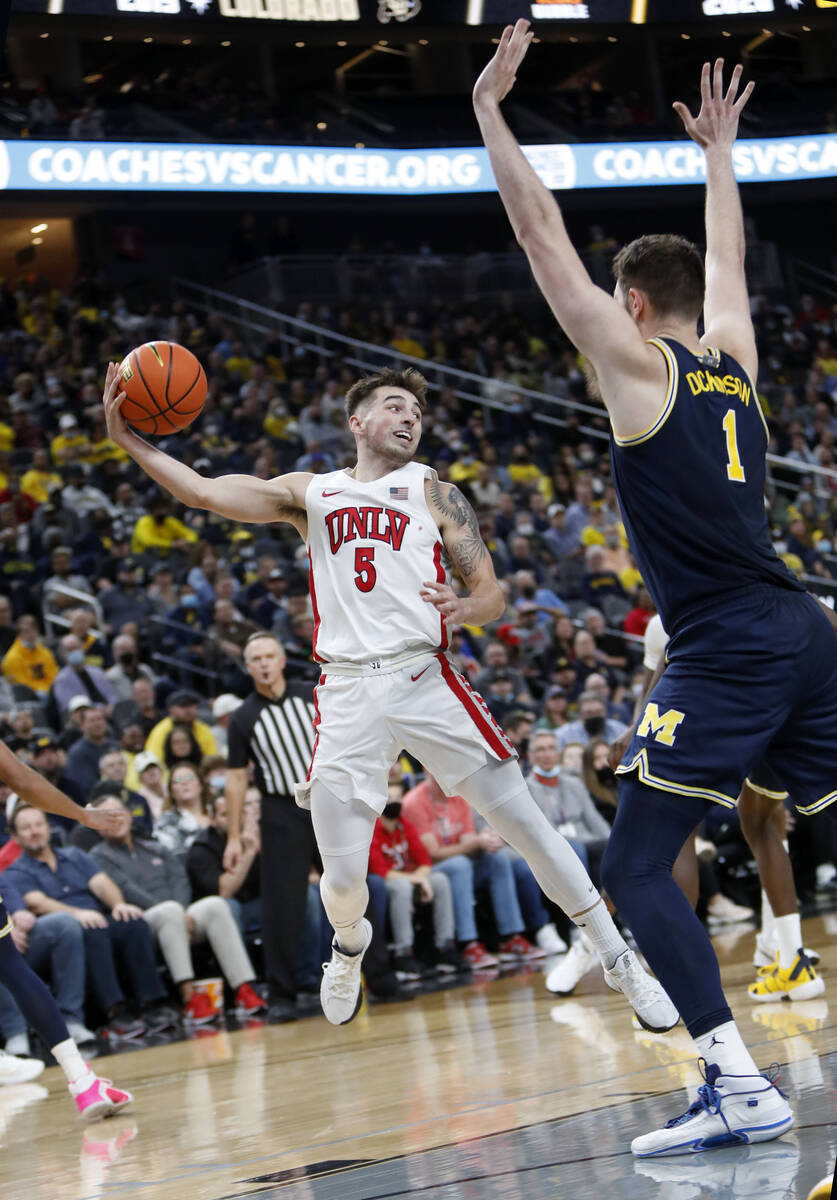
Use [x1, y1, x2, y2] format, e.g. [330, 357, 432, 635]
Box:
[613, 233, 705, 320]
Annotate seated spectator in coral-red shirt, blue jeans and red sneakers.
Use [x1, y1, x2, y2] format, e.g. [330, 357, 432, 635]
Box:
[402, 775, 543, 971]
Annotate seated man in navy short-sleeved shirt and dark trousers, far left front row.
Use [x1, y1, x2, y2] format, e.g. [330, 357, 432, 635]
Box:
[6, 805, 170, 1038]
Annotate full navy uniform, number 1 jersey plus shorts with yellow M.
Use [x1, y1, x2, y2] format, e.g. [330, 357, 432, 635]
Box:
[610, 338, 837, 812]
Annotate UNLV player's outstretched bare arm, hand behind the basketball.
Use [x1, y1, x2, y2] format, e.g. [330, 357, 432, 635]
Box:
[103, 362, 311, 524]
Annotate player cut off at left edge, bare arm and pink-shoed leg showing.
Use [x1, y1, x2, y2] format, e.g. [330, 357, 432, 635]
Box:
[0, 742, 133, 1121]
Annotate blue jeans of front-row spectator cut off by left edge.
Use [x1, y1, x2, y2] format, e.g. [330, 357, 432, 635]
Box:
[0, 912, 85, 1039]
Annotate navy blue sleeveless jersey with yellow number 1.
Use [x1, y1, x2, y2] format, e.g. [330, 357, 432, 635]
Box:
[610, 337, 805, 636]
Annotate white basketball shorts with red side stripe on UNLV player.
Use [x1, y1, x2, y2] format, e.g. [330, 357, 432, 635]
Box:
[296, 654, 517, 814]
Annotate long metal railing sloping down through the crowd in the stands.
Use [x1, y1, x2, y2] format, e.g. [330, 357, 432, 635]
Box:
[173, 278, 837, 493]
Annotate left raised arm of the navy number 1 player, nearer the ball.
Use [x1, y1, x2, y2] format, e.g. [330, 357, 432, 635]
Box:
[474, 20, 660, 422]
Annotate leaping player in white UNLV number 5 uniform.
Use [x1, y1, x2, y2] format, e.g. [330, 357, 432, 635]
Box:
[104, 365, 678, 1030]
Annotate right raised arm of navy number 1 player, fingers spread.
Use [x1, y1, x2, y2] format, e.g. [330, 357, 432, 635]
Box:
[674, 59, 758, 380]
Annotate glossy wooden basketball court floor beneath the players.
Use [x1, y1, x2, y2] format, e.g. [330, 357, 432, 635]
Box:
[0, 916, 837, 1200]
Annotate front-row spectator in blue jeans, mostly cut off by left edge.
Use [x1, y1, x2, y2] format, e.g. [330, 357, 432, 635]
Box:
[0, 876, 96, 1058]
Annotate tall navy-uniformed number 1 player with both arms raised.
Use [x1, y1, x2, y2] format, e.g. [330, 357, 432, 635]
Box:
[474, 20, 837, 1156]
